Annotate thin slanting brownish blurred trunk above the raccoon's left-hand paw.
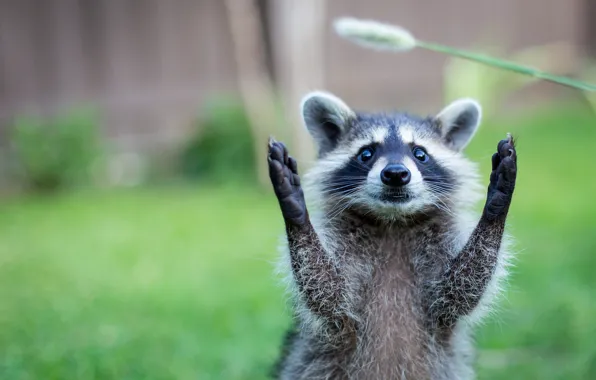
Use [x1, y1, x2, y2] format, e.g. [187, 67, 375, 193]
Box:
[225, 0, 277, 187]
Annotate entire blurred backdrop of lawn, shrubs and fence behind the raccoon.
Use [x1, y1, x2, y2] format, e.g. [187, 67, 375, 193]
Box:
[0, 0, 596, 379]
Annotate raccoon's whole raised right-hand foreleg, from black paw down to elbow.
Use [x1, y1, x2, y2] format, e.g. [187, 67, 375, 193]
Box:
[435, 136, 517, 326]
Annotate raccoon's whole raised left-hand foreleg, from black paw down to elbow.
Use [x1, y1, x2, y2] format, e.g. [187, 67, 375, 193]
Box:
[267, 139, 344, 325]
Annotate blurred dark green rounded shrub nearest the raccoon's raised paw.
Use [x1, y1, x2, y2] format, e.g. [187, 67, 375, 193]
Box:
[181, 99, 256, 182]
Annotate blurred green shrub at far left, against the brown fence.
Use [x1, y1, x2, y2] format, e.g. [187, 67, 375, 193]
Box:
[11, 110, 99, 192]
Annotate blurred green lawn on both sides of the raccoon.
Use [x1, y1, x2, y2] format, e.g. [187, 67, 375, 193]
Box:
[0, 102, 596, 380]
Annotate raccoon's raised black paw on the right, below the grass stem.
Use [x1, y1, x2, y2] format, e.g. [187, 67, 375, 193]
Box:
[484, 135, 517, 219]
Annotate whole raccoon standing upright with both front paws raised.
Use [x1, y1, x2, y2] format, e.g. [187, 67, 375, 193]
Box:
[267, 91, 517, 379]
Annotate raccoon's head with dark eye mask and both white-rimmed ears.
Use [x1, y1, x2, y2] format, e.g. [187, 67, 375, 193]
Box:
[302, 92, 481, 219]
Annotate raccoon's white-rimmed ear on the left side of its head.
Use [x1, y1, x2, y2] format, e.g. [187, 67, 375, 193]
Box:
[301, 91, 356, 154]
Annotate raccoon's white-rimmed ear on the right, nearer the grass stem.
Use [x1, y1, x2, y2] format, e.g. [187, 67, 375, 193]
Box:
[435, 98, 482, 151]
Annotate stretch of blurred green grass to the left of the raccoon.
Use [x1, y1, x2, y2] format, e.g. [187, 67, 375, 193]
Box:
[0, 189, 286, 379]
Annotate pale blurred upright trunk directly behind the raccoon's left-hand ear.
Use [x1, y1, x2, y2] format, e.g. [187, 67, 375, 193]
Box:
[270, 0, 328, 167]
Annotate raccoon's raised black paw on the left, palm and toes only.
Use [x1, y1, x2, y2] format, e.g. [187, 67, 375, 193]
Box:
[267, 138, 308, 226]
